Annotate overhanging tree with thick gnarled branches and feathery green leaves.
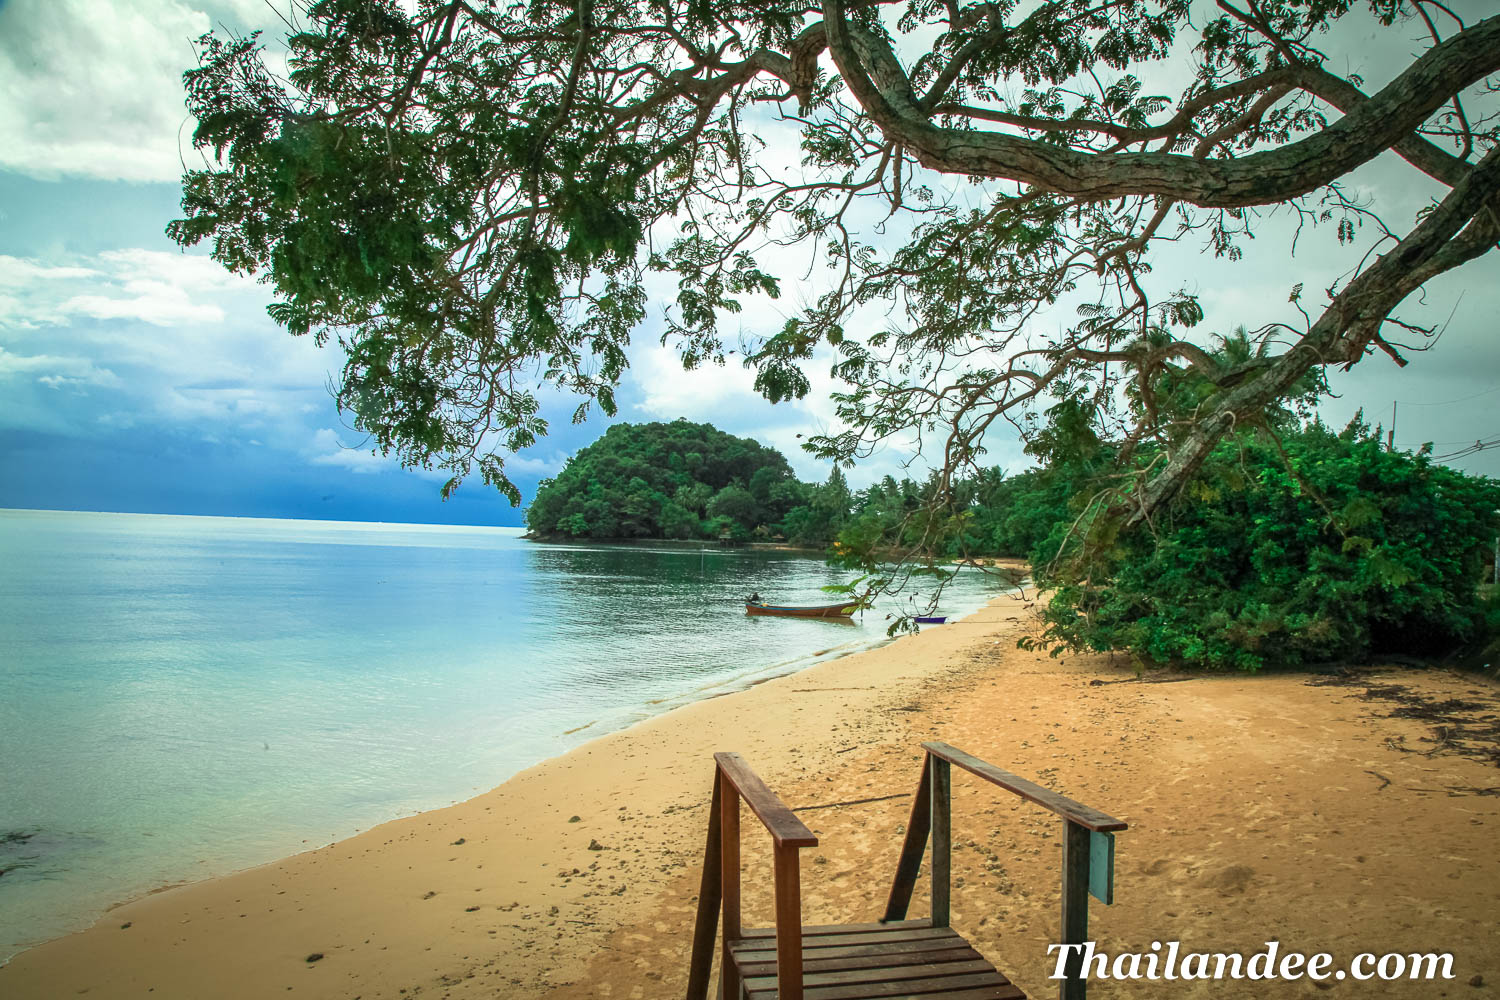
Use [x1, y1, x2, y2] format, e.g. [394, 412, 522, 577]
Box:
[170, 0, 1500, 523]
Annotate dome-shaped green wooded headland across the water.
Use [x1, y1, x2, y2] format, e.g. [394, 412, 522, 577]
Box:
[527, 420, 849, 546]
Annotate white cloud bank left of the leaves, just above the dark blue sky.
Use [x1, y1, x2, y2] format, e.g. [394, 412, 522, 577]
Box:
[0, 239, 342, 453]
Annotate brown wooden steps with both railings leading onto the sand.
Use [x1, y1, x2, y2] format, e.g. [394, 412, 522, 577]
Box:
[687, 742, 1125, 1000]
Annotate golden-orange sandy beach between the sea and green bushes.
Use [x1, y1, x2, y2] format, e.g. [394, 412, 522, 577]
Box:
[0, 597, 1500, 1000]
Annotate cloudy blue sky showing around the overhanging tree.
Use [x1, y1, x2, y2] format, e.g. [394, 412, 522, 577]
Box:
[0, 0, 1500, 525]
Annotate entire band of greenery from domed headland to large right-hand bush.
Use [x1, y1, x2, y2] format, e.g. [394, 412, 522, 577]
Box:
[527, 405, 1500, 670]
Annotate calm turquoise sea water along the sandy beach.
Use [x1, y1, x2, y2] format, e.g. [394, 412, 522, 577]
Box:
[0, 511, 995, 961]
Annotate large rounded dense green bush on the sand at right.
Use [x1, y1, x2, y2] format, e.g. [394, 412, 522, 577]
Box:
[1037, 418, 1500, 670]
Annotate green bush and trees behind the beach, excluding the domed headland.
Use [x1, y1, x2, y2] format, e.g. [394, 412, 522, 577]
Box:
[839, 406, 1500, 670]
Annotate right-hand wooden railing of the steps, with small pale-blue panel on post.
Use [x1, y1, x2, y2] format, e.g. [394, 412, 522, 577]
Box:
[876, 742, 1127, 1000]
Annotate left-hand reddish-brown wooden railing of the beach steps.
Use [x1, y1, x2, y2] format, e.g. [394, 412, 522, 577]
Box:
[687, 753, 818, 1000]
